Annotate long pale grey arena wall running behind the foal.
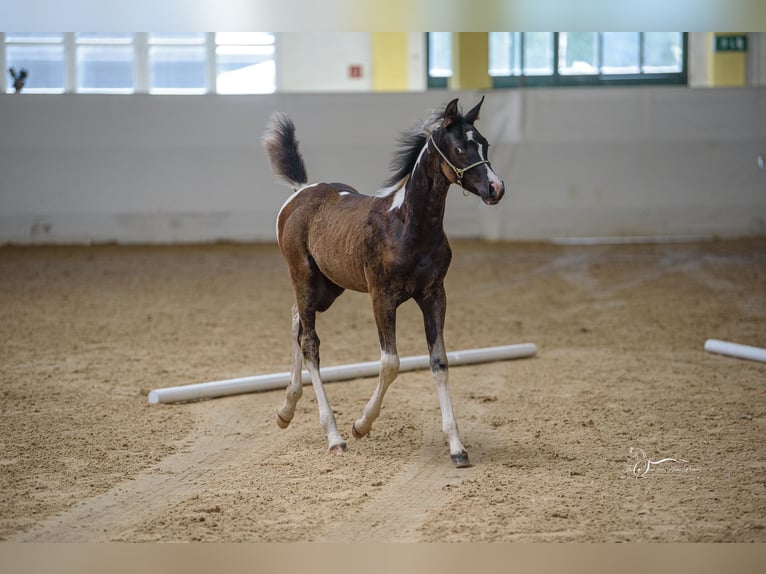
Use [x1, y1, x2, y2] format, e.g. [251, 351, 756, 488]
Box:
[0, 87, 766, 243]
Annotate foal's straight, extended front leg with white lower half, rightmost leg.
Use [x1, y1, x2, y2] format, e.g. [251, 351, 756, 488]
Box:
[416, 285, 471, 468]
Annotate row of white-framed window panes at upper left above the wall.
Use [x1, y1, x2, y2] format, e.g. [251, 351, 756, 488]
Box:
[0, 32, 276, 94]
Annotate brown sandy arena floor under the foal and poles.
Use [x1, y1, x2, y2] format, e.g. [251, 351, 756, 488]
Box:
[0, 240, 766, 542]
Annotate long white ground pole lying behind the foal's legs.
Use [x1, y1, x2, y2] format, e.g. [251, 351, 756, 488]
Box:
[149, 343, 537, 405]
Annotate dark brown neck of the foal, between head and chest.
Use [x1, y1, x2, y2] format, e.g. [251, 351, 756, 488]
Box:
[402, 148, 450, 235]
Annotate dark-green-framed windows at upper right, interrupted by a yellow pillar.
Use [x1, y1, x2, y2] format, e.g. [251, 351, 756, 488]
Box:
[429, 32, 687, 88]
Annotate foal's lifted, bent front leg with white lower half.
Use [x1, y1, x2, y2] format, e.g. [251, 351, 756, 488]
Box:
[351, 294, 399, 438]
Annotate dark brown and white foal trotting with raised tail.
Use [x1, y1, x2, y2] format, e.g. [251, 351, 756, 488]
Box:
[263, 98, 505, 467]
